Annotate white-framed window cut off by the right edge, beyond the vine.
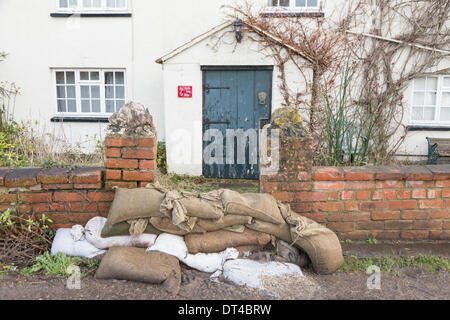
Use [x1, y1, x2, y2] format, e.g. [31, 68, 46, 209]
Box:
[411, 74, 450, 126]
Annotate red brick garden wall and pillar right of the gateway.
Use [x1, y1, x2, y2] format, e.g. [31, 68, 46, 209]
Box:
[260, 139, 450, 240]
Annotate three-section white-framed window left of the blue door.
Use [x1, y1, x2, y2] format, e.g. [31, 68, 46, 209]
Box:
[54, 69, 126, 117]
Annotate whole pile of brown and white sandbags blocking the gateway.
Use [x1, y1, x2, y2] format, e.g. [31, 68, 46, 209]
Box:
[52, 185, 343, 293]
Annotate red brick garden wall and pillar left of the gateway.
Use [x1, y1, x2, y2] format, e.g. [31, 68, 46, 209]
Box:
[0, 134, 157, 229]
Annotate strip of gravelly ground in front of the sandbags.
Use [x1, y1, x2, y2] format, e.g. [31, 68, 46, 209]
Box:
[0, 267, 450, 300]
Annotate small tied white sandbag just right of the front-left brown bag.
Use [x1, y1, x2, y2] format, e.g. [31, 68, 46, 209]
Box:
[181, 248, 239, 273]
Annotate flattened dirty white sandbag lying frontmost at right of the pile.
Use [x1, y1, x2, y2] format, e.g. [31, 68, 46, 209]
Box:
[223, 259, 303, 290]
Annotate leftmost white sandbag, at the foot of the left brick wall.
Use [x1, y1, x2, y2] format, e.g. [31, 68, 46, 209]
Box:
[50, 229, 106, 259]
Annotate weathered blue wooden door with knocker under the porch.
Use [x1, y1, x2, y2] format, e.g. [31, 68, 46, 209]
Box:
[203, 67, 273, 179]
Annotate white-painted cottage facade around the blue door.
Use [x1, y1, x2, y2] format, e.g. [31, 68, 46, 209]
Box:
[0, 0, 450, 175]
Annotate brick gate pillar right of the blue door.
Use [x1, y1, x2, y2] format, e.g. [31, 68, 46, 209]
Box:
[259, 138, 313, 213]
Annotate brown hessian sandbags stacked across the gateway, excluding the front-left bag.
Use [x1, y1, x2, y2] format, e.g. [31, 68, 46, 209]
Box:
[101, 185, 343, 274]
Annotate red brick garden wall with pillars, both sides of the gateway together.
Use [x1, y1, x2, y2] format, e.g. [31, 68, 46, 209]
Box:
[0, 132, 450, 240]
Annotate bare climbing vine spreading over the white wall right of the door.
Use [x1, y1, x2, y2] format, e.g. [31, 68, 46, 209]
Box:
[224, 0, 450, 165]
